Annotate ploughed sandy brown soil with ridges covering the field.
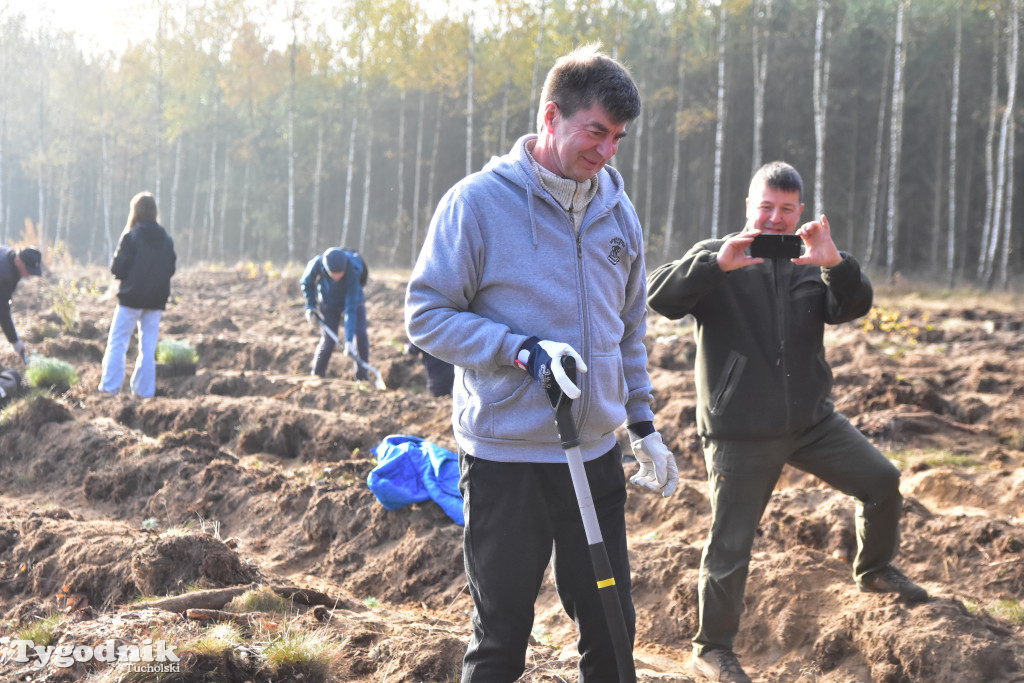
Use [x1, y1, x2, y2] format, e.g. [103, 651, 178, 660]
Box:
[0, 266, 1024, 683]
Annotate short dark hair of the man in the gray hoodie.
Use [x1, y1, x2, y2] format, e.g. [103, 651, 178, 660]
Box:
[537, 43, 640, 131]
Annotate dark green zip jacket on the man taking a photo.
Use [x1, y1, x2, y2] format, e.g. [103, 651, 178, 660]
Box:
[647, 236, 873, 438]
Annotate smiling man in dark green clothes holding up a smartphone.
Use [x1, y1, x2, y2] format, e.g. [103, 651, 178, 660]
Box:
[647, 162, 928, 683]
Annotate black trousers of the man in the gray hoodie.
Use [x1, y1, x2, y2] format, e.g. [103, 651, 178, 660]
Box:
[459, 444, 636, 683]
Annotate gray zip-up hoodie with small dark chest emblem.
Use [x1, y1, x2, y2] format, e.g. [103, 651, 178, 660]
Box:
[406, 135, 653, 463]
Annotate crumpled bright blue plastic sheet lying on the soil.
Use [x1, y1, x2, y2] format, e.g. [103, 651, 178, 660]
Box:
[367, 434, 466, 525]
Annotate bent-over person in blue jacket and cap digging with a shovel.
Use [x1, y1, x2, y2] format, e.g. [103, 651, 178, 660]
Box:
[299, 247, 370, 381]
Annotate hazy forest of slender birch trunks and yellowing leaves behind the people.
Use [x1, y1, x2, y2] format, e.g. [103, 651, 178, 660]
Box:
[0, 0, 1024, 289]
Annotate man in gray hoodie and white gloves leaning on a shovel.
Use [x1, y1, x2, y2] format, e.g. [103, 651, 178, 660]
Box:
[406, 45, 679, 683]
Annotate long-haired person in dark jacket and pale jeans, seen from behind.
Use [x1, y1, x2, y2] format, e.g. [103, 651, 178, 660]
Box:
[99, 193, 177, 398]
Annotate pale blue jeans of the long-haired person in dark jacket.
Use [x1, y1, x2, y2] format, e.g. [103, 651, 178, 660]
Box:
[99, 304, 164, 398]
